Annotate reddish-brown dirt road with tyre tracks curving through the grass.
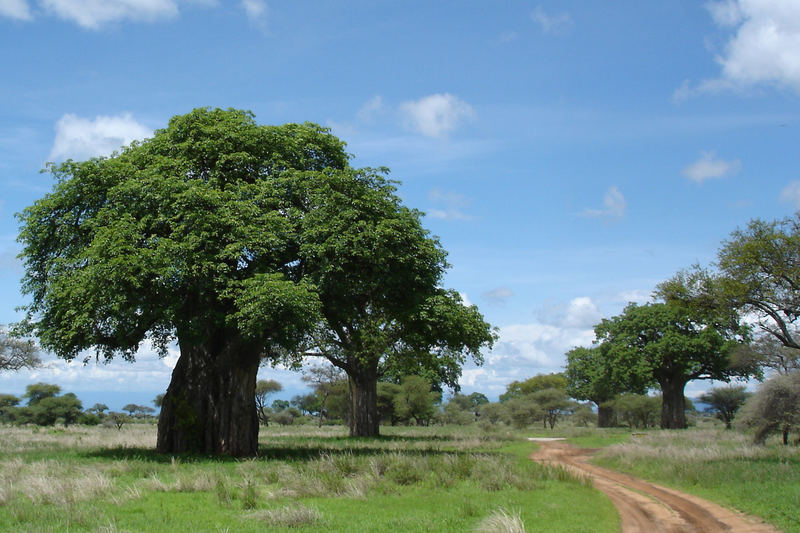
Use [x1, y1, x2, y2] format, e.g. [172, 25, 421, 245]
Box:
[530, 439, 778, 533]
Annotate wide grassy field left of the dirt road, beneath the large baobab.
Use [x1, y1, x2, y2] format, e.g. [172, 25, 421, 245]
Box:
[0, 424, 619, 532]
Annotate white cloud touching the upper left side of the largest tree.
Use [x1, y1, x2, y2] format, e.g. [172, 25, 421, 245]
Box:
[50, 113, 153, 161]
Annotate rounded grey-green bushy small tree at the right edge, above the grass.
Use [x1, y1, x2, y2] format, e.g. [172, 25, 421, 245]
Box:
[736, 372, 800, 444]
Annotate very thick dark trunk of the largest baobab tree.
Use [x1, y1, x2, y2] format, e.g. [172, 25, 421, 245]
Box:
[157, 339, 259, 457]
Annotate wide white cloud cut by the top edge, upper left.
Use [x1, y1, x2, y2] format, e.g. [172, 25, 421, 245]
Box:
[39, 0, 178, 29]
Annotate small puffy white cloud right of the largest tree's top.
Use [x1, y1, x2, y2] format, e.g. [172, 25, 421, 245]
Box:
[400, 93, 475, 137]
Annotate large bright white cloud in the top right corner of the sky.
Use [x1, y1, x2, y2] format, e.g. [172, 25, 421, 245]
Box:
[701, 0, 800, 92]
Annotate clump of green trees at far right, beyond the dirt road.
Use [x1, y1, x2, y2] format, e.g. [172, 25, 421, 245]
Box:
[566, 213, 800, 444]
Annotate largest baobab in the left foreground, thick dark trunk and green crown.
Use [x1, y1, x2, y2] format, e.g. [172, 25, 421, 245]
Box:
[14, 109, 352, 455]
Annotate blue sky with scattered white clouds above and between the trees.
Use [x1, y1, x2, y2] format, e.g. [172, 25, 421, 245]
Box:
[0, 0, 800, 408]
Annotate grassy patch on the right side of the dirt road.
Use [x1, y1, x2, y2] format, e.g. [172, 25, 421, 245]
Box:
[595, 429, 800, 533]
